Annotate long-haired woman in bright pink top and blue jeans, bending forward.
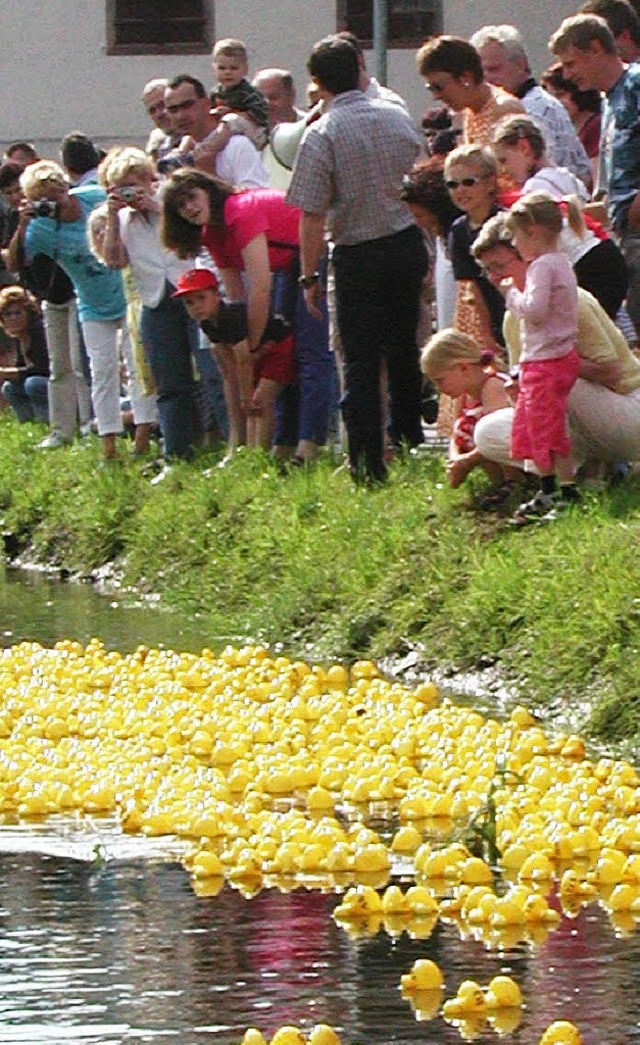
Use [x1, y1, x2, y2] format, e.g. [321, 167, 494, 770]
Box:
[163, 169, 335, 461]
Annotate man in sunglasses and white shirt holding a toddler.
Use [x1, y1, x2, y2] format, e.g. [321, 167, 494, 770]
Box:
[165, 73, 269, 188]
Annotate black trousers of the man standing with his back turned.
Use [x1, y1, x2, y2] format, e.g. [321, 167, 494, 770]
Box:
[334, 226, 429, 480]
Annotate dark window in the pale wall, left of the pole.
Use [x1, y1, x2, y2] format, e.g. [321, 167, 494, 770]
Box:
[107, 0, 213, 54]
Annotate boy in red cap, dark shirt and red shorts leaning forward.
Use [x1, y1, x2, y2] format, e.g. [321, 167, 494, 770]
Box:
[174, 269, 296, 449]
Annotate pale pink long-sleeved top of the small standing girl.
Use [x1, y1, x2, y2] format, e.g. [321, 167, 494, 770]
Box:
[506, 251, 577, 363]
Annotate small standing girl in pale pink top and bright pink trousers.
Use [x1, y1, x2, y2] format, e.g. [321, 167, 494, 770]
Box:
[503, 192, 579, 526]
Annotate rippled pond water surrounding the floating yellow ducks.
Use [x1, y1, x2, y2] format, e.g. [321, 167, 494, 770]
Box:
[0, 574, 640, 1045]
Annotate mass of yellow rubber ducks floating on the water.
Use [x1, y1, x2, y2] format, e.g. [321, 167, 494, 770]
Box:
[0, 640, 640, 1045]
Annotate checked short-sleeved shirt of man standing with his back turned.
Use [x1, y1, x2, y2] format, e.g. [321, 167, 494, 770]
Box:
[287, 91, 420, 247]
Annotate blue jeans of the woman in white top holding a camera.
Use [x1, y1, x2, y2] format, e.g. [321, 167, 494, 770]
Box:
[140, 289, 199, 458]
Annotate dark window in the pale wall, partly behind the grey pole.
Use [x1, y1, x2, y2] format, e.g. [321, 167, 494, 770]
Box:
[338, 0, 442, 47]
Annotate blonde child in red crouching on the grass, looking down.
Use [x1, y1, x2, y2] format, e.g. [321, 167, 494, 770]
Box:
[420, 328, 523, 510]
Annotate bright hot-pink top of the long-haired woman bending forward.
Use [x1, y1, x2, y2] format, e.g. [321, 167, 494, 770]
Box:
[202, 189, 300, 272]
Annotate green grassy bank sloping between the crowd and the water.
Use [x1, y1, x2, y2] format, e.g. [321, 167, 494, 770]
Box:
[0, 415, 640, 743]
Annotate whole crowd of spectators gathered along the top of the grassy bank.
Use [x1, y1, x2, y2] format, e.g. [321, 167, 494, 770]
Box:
[0, 0, 640, 526]
